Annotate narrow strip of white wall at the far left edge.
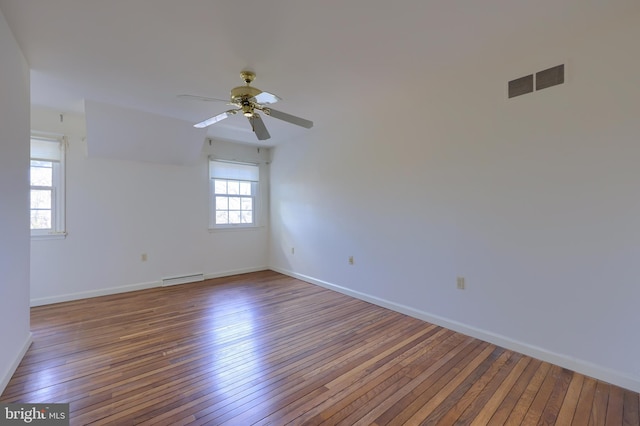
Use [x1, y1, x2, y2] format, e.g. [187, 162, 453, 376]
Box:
[0, 12, 31, 394]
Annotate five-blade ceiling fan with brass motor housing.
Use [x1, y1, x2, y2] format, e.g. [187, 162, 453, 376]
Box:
[179, 71, 313, 141]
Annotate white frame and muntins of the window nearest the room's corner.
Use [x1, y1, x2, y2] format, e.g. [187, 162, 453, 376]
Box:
[208, 158, 261, 230]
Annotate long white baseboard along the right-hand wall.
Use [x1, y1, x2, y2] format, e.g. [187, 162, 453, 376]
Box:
[271, 267, 640, 392]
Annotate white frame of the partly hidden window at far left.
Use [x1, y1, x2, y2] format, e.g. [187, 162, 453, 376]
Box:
[29, 133, 67, 239]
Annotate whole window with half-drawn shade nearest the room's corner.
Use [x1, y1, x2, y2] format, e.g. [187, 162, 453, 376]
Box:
[209, 160, 260, 228]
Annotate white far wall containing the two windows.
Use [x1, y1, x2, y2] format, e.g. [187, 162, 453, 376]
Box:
[31, 107, 269, 305]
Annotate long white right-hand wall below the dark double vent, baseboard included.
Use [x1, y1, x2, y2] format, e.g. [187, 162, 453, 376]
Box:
[270, 16, 640, 391]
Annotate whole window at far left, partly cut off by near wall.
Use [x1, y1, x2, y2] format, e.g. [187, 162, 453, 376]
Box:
[29, 136, 65, 237]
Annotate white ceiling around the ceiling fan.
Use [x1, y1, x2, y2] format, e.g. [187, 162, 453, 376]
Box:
[0, 0, 638, 145]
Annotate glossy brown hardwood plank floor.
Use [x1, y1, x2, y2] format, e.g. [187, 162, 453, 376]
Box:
[0, 271, 640, 426]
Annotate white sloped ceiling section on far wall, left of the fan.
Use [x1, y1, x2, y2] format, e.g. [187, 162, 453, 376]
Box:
[84, 100, 206, 165]
